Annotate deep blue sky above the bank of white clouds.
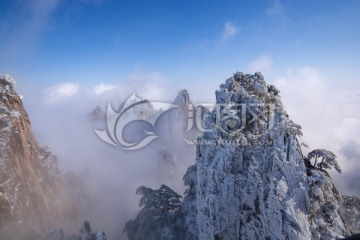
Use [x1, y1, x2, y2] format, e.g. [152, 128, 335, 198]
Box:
[0, 0, 360, 89]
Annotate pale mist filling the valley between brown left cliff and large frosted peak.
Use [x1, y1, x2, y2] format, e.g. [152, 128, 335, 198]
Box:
[18, 74, 210, 239]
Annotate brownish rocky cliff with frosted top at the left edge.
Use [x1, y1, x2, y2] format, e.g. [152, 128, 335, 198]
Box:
[0, 75, 62, 239]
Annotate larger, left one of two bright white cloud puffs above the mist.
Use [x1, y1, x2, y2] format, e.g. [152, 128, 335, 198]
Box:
[44, 82, 80, 104]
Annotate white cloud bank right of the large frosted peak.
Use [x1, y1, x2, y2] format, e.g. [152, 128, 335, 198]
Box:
[274, 67, 360, 185]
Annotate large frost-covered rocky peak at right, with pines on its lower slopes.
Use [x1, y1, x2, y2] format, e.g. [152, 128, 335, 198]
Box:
[124, 72, 360, 240]
